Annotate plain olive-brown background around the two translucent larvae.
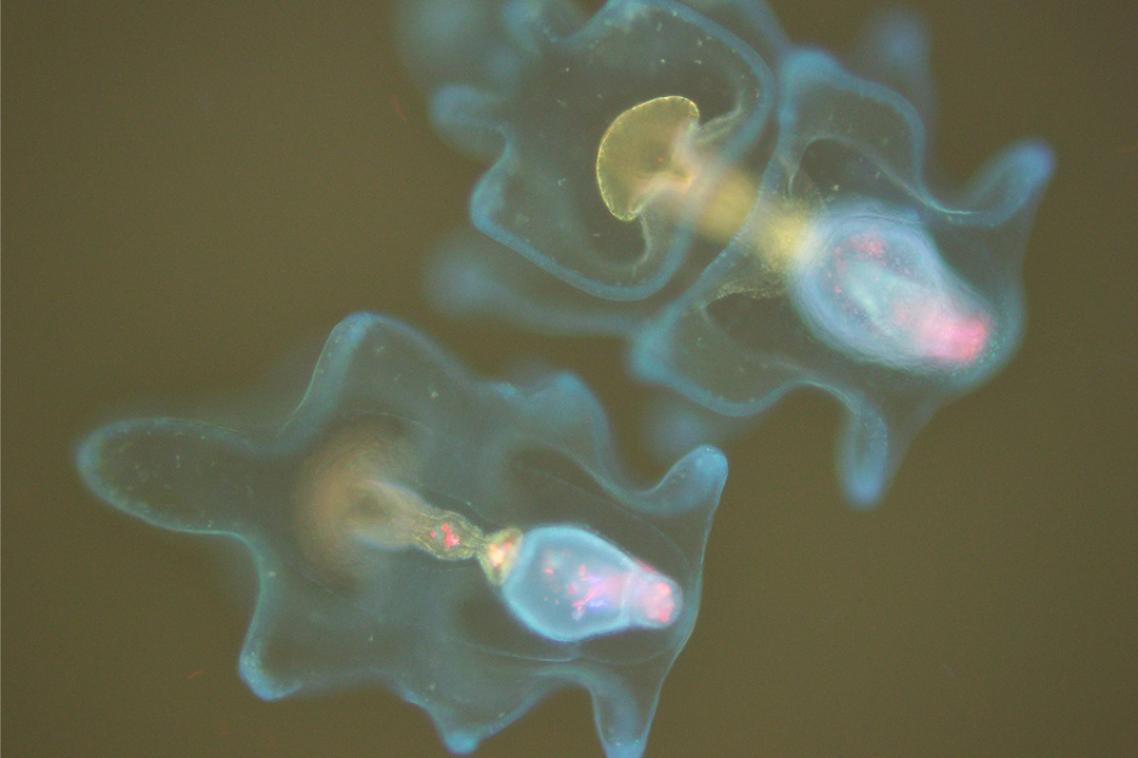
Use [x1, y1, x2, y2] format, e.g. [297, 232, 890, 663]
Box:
[2, 0, 1138, 757]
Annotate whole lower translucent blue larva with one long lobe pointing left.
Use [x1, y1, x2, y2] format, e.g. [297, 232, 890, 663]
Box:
[77, 314, 726, 756]
